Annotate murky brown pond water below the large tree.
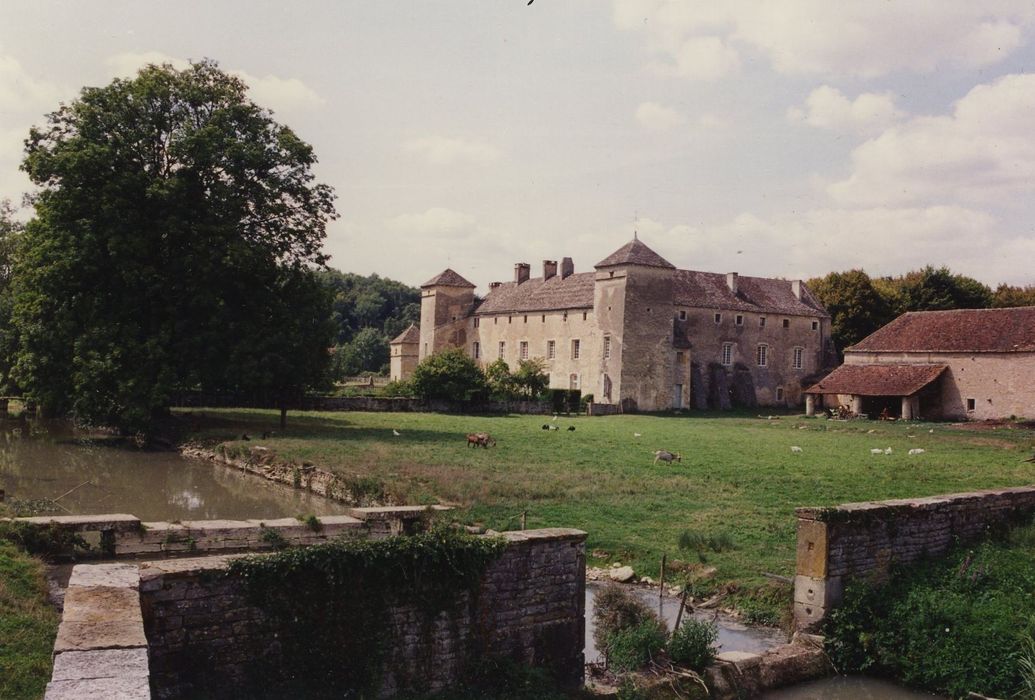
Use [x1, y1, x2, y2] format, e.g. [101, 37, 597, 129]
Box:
[0, 420, 346, 520]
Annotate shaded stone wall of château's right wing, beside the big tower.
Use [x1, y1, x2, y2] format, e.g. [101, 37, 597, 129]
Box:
[676, 307, 830, 406]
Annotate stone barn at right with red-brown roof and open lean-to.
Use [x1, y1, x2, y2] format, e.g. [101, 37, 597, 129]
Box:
[806, 307, 1035, 419]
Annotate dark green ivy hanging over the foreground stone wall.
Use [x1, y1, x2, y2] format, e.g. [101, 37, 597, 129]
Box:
[226, 526, 505, 698]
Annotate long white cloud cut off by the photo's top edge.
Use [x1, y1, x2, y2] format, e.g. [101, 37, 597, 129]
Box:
[614, 0, 1035, 78]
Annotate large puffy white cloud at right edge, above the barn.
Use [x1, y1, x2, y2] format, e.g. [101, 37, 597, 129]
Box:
[827, 75, 1035, 206]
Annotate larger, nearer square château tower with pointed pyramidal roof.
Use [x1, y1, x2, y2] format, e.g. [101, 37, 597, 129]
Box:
[593, 237, 689, 411]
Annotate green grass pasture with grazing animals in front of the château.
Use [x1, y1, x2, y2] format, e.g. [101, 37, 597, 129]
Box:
[186, 409, 1035, 625]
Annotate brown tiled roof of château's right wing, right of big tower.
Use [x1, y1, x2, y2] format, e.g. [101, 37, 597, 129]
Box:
[674, 270, 829, 318]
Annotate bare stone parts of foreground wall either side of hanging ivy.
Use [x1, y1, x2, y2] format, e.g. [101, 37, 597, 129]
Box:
[140, 529, 586, 698]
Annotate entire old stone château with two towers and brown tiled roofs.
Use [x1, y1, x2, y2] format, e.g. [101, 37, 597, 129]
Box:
[392, 237, 830, 411]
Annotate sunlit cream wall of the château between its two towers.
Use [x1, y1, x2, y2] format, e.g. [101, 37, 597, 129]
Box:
[466, 309, 602, 393]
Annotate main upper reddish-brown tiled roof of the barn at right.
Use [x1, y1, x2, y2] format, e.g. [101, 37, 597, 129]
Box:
[846, 307, 1035, 352]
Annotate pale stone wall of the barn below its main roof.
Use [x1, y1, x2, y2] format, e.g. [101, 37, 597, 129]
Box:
[845, 352, 1035, 420]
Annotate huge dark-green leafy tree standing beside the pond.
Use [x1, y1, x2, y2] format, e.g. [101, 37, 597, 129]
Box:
[11, 61, 336, 430]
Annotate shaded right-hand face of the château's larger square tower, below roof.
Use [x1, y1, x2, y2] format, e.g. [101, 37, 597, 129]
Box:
[597, 266, 676, 411]
